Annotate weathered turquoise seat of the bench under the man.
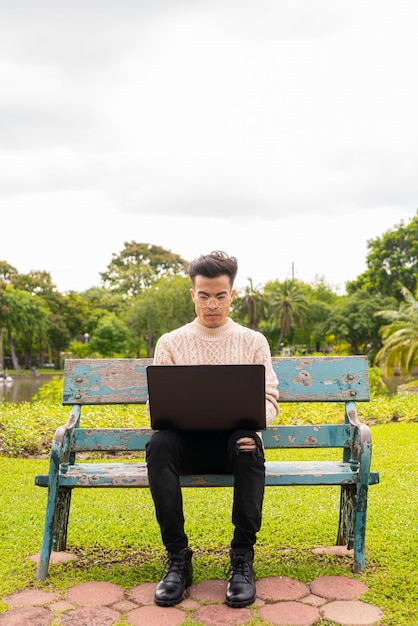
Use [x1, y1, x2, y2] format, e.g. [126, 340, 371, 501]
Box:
[35, 461, 378, 488]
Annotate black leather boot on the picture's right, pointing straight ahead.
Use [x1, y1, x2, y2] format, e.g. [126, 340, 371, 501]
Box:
[225, 550, 255, 609]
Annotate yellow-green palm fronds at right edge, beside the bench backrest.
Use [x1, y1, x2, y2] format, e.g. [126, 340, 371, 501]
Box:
[376, 285, 418, 376]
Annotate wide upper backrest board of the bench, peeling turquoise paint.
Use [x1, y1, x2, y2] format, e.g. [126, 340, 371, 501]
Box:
[63, 356, 370, 405]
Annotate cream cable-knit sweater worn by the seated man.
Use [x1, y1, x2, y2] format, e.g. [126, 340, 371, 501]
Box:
[154, 318, 279, 424]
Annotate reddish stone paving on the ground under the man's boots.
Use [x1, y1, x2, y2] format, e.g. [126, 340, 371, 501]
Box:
[0, 552, 383, 626]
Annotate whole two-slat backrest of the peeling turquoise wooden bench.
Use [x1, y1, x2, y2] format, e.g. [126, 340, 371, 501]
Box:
[58, 356, 370, 458]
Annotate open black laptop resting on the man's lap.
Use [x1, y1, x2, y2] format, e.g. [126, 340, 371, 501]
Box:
[147, 364, 266, 431]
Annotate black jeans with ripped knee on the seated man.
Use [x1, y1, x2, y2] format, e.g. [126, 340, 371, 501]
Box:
[146, 430, 265, 552]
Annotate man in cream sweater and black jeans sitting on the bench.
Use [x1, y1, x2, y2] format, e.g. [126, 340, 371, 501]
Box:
[147, 251, 279, 608]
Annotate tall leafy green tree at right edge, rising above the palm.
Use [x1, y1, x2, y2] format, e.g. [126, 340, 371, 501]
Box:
[347, 213, 418, 302]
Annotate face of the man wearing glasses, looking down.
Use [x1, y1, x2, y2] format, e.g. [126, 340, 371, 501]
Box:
[190, 275, 235, 328]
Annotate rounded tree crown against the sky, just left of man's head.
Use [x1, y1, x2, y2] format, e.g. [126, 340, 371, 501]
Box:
[100, 241, 188, 296]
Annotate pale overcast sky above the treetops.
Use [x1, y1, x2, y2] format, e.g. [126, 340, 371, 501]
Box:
[0, 0, 418, 293]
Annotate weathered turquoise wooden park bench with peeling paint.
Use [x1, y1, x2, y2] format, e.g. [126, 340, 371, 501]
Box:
[35, 356, 379, 580]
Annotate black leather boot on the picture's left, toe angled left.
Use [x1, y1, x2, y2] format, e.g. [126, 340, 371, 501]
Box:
[154, 548, 193, 606]
